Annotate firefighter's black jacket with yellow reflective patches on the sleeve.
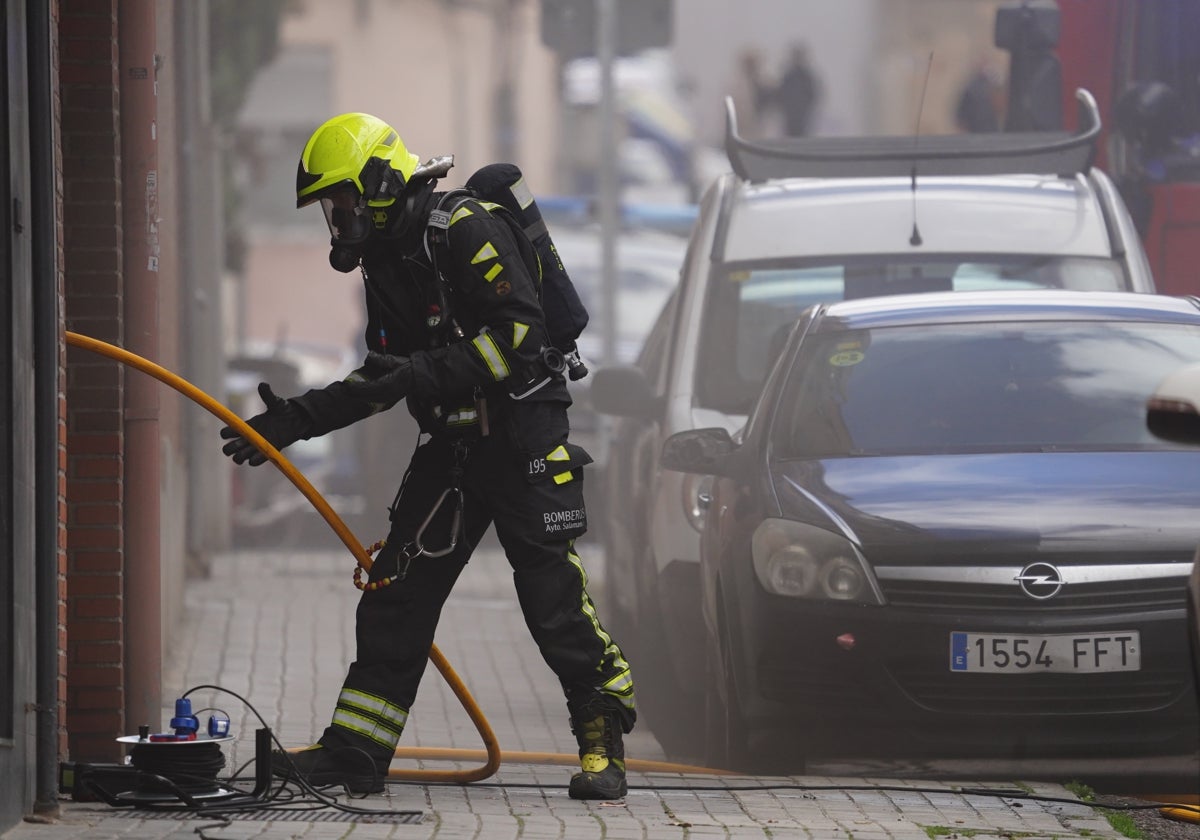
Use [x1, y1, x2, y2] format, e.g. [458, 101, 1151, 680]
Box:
[290, 193, 570, 449]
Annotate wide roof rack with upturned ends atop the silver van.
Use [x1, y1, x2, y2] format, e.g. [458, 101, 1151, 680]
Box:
[725, 88, 1100, 182]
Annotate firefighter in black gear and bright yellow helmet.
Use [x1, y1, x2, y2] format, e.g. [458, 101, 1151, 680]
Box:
[221, 113, 636, 799]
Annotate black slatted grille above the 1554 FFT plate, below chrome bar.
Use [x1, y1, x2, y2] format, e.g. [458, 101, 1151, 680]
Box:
[880, 578, 1187, 612]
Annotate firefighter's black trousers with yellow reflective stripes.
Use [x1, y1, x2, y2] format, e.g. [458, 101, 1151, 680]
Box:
[320, 437, 636, 767]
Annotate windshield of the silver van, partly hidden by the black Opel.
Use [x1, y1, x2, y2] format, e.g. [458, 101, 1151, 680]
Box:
[696, 254, 1127, 413]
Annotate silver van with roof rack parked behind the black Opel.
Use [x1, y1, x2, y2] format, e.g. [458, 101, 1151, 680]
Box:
[592, 91, 1154, 755]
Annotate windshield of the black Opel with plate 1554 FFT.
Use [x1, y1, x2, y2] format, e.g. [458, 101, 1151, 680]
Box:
[773, 322, 1200, 457]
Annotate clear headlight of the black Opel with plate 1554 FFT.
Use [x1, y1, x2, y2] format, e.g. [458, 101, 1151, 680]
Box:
[750, 520, 883, 605]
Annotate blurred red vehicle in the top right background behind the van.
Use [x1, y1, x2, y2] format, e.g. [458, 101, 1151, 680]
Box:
[1056, 0, 1200, 294]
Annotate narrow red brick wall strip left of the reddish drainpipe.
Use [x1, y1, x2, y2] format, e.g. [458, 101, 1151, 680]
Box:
[59, 0, 126, 761]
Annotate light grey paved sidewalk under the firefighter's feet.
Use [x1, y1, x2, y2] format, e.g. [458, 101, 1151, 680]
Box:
[2, 548, 1121, 840]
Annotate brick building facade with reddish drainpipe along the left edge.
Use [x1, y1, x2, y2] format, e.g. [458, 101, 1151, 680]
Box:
[0, 0, 220, 830]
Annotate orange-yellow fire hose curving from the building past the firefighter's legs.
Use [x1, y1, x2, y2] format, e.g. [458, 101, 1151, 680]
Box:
[66, 330, 722, 784]
